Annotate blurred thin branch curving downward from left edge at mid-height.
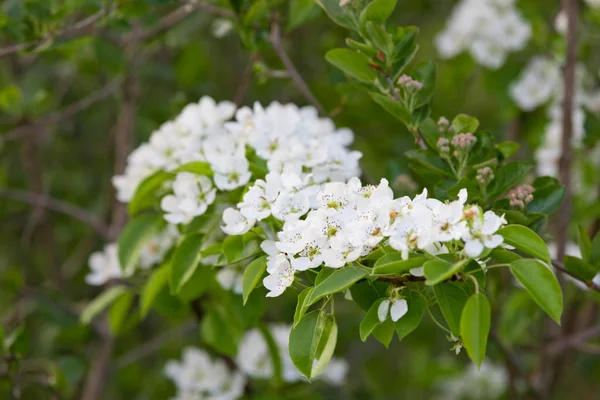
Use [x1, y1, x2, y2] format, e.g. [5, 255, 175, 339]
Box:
[0, 189, 108, 237]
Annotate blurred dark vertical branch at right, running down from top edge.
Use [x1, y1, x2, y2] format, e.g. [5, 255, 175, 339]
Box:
[556, 0, 577, 260]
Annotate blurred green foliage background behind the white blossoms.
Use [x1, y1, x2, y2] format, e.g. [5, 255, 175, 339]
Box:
[0, 0, 600, 399]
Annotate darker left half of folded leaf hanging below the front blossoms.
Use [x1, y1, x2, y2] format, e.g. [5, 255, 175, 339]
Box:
[289, 310, 327, 380]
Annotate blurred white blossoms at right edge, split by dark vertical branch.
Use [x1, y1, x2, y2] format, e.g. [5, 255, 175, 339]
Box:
[510, 56, 600, 176]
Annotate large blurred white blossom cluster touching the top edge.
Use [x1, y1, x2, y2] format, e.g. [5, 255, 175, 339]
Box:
[435, 0, 531, 69]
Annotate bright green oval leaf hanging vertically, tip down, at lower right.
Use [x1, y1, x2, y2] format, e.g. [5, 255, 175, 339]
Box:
[460, 293, 492, 368]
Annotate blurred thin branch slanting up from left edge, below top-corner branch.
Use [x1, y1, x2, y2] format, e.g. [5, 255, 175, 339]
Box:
[0, 79, 121, 141]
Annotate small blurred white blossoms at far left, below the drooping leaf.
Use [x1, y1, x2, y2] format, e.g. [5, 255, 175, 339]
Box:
[85, 225, 179, 286]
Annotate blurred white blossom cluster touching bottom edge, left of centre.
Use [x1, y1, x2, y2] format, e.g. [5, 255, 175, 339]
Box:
[165, 347, 246, 400]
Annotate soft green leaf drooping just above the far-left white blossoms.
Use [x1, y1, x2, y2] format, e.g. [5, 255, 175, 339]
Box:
[118, 214, 162, 271]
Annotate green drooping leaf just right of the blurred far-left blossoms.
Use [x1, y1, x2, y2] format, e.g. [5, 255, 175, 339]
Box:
[169, 233, 204, 294]
